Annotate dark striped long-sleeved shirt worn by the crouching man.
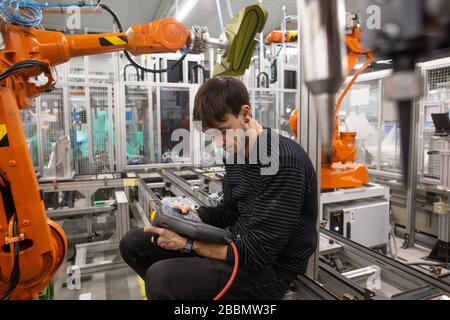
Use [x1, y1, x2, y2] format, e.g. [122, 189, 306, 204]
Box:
[198, 129, 317, 279]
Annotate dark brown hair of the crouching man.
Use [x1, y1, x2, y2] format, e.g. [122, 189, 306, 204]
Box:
[194, 76, 250, 130]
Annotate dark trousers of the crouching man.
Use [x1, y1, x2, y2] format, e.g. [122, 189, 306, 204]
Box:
[120, 229, 289, 300]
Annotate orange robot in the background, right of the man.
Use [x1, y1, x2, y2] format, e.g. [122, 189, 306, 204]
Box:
[284, 14, 372, 189]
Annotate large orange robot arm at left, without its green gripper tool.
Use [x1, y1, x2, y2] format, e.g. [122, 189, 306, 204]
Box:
[0, 18, 190, 299]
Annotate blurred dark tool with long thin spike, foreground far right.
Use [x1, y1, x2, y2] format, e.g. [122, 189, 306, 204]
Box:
[363, 0, 450, 248]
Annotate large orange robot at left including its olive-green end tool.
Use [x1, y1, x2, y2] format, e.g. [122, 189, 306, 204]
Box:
[0, 1, 267, 299]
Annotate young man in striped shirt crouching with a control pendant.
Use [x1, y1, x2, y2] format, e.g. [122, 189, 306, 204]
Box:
[120, 77, 317, 300]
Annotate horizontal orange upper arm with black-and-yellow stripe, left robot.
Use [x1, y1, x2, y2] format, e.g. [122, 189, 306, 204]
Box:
[2, 18, 190, 75]
